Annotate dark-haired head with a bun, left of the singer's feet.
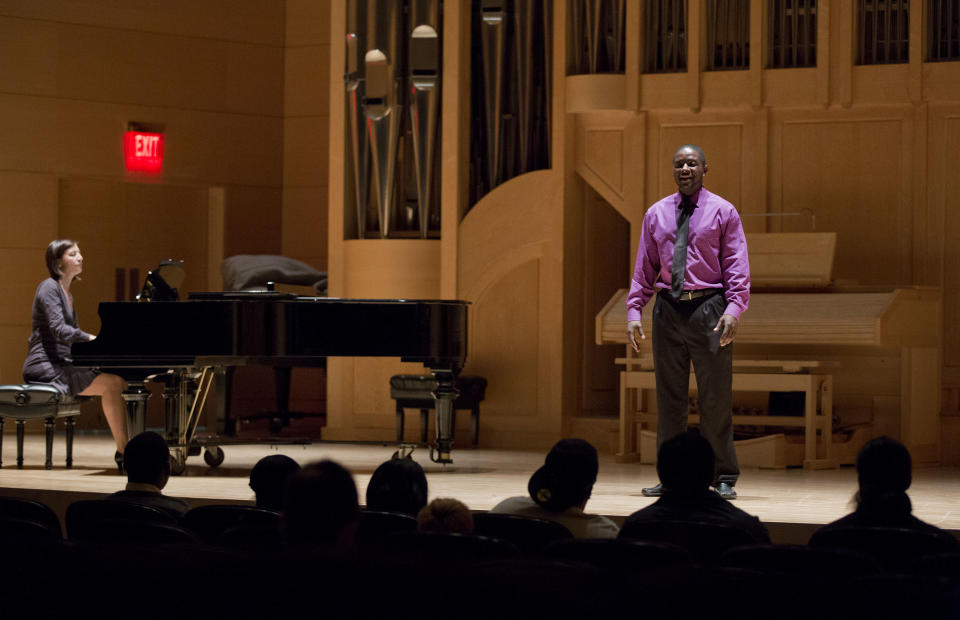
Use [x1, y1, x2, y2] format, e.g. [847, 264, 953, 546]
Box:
[527, 439, 600, 512]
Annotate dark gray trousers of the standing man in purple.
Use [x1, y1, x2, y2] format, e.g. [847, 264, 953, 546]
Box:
[653, 290, 740, 485]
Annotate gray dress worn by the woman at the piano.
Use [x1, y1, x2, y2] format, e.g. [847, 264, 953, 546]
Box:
[23, 278, 97, 396]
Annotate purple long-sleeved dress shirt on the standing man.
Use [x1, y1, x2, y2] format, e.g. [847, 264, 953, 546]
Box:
[627, 188, 750, 321]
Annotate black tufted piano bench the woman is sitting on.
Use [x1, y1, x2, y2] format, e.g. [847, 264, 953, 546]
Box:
[0, 383, 87, 469]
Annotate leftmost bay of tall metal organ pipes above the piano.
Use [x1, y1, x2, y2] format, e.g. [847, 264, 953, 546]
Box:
[344, 0, 442, 239]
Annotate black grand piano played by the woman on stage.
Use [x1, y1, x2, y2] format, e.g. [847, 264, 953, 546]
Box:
[72, 291, 468, 472]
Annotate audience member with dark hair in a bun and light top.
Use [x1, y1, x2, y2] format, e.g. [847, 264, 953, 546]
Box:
[490, 439, 619, 538]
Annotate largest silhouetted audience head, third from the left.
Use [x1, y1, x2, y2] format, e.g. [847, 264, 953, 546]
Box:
[281, 460, 360, 555]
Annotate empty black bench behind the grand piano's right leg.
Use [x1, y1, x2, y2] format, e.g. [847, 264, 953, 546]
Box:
[390, 375, 487, 446]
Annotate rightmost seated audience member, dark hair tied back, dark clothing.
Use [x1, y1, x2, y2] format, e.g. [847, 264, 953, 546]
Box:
[820, 437, 960, 551]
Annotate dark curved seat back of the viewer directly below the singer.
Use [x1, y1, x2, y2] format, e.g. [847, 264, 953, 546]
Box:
[619, 520, 756, 563]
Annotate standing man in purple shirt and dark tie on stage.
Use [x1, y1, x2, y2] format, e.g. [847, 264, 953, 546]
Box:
[627, 144, 750, 499]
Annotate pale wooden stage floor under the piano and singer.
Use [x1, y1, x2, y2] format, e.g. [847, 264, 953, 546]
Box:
[0, 433, 960, 543]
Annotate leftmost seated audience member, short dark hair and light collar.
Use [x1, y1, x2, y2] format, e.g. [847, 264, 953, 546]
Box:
[107, 431, 190, 519]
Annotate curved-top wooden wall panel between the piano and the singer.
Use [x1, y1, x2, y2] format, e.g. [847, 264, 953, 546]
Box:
[457, 170, 564, 447]
